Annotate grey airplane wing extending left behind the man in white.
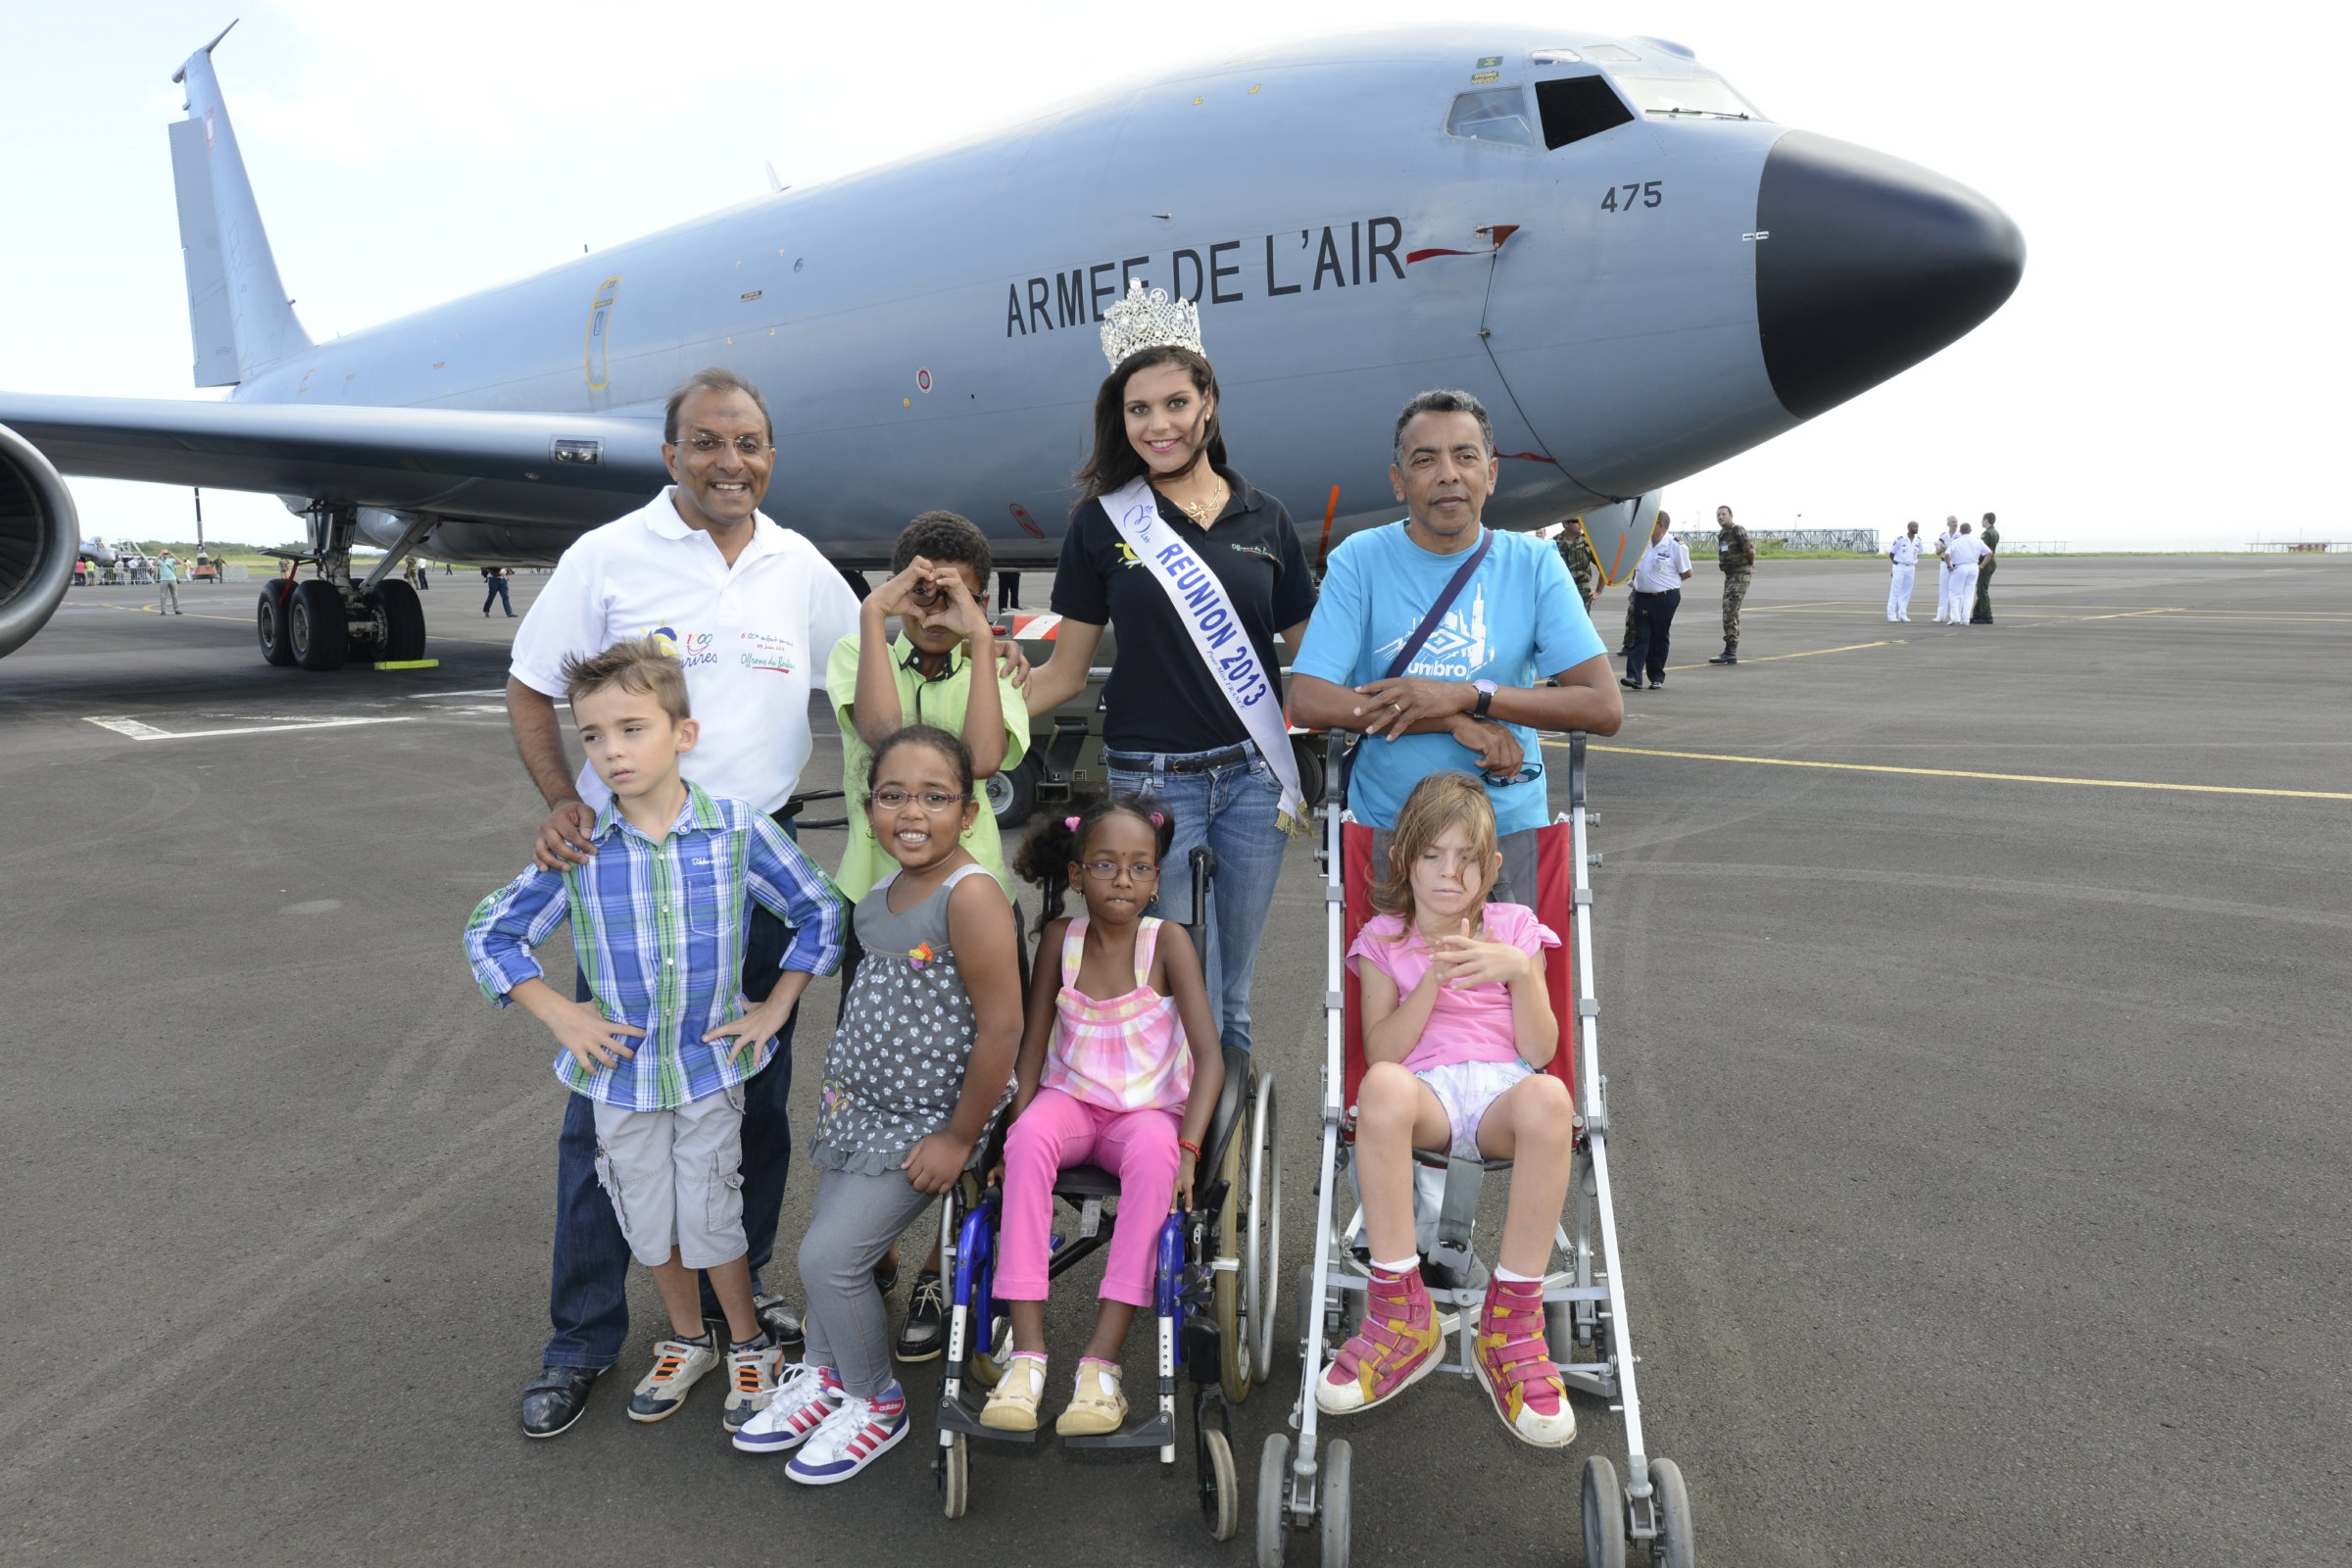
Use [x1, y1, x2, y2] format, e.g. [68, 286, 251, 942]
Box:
[0, 393, 668, 529]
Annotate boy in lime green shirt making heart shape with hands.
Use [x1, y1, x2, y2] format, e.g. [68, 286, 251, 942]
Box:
[825, 513, 1028, 1361]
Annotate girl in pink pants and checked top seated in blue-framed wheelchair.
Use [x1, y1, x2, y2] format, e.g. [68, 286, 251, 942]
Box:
[981, 795, 1225, 1437]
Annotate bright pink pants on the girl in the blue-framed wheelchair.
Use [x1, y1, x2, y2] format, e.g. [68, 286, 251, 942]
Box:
[998, 1089, 1183, 1307]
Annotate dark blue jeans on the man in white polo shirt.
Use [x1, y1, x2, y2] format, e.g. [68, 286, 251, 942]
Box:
[541, 893, 800, 1368]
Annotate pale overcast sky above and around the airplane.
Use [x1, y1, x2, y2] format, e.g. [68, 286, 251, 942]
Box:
[0, 0, 2352, 548]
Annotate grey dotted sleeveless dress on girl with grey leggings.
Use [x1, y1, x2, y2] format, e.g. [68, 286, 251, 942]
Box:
[809, 865, 1013, 1175]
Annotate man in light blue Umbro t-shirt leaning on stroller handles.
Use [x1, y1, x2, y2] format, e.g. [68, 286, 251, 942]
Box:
[1292, 393, 1625, 903]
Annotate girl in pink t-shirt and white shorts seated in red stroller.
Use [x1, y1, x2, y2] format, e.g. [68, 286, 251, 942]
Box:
[1315, 773, 1576, 1448]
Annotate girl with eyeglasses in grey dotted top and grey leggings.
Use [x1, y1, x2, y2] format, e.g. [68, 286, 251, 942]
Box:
[734, 724, 1021, 1486]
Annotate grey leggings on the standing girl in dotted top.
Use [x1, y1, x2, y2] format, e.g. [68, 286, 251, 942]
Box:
[800, 1171, 939, 1398]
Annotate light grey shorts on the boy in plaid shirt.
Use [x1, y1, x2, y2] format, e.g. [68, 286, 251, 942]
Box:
[595, 1086, 751, 1269]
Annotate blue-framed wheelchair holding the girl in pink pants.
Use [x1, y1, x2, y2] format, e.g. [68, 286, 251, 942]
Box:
[931, 849, 1282, 1540]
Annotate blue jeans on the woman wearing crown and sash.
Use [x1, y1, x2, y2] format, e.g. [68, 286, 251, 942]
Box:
[1103, 750, 1289, 1051]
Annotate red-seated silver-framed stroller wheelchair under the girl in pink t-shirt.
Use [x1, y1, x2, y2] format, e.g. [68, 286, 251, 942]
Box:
[1256, 733, 1693, 1568]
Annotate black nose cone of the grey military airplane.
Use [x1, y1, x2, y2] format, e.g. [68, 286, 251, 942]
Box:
[1757, 131, 2025, 418]
